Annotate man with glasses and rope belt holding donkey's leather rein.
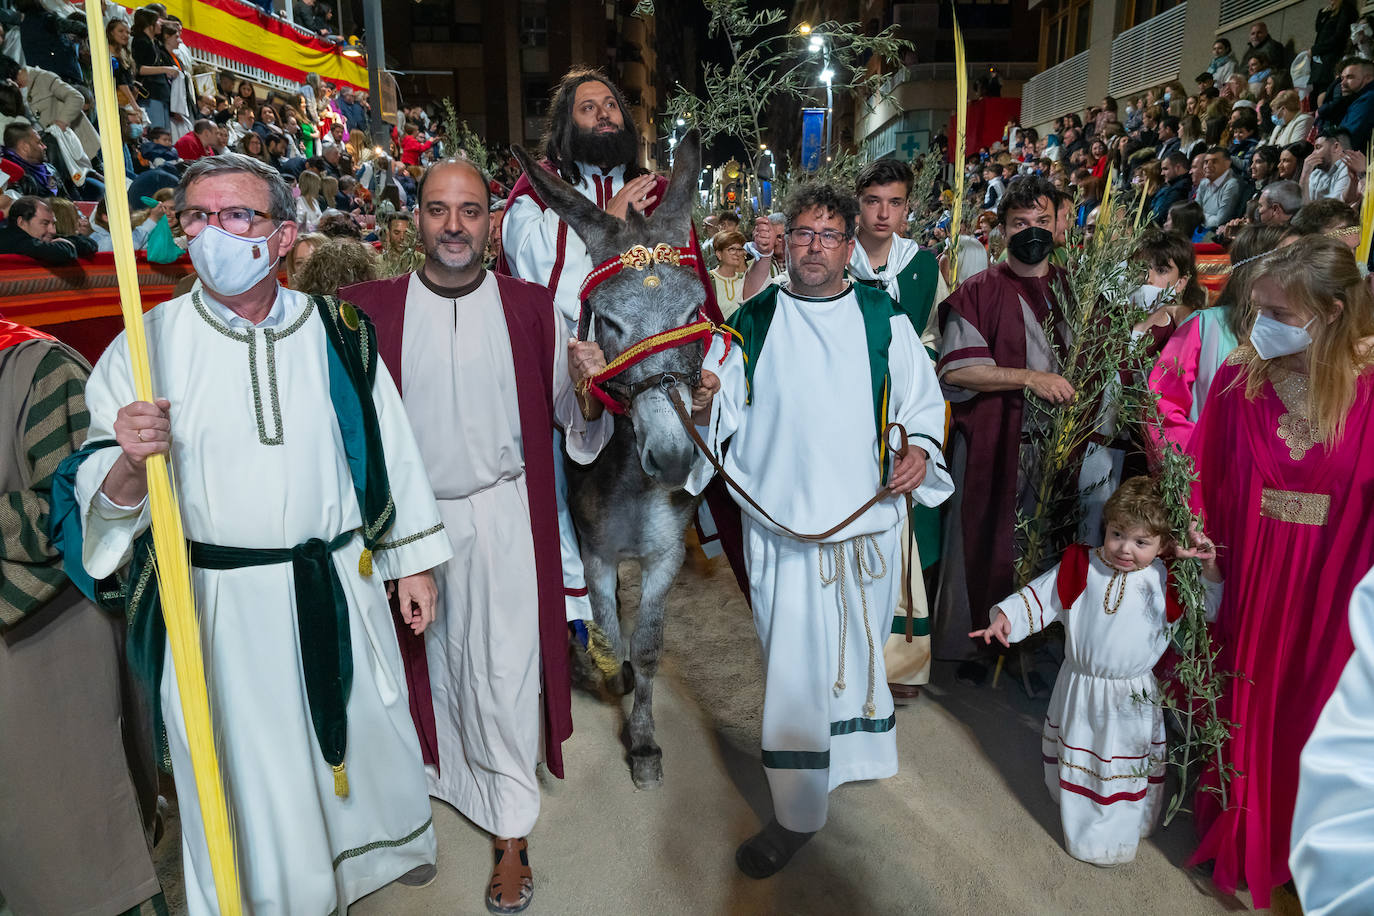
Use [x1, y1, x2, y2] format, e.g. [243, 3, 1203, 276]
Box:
[688, 183, 952, 878]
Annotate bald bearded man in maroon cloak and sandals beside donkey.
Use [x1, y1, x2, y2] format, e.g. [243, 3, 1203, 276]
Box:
[339, 159, 613, 912]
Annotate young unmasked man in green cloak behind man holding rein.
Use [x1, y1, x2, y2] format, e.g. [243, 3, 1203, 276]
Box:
[849, 159, 949, 699]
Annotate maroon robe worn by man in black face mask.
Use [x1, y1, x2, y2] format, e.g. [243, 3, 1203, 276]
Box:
[936, 264, 1068, 658]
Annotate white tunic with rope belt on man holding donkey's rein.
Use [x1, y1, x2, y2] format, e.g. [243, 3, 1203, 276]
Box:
[688, 282, 952, 831]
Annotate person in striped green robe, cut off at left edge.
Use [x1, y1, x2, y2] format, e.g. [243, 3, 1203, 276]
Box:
[0, 319, 166, 916]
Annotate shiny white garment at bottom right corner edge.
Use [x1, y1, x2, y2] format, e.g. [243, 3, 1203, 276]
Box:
[1289, 563, 1374, 916]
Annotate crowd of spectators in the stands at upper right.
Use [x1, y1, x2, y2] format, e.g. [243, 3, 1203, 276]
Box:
[965, 9, 1374, 260]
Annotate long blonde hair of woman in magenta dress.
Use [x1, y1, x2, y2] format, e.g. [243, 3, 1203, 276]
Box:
[1243, 235, 1374, 445]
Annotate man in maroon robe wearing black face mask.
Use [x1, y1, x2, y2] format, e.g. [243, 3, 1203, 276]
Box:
[932, 176, 1073, 681]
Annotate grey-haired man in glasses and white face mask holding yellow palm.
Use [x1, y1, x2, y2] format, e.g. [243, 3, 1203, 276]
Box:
[54, 154, 452, 916]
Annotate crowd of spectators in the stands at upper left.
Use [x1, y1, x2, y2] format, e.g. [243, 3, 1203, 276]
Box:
[0, 0, 478, 284]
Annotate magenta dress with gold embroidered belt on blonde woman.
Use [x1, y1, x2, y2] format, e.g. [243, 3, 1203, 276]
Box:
[1189, 346, 1374, 908]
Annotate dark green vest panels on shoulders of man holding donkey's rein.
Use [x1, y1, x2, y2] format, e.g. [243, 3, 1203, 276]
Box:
[725, 283, 897, 483]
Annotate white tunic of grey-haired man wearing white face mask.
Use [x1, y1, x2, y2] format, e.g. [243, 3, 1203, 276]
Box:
[77, 290, 452, 916]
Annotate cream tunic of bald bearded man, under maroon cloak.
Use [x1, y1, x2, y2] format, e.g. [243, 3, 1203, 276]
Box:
[401, 273, 614, 836]
